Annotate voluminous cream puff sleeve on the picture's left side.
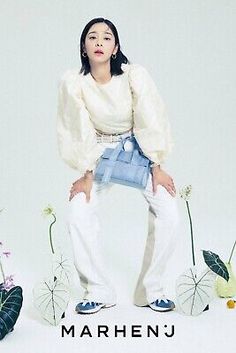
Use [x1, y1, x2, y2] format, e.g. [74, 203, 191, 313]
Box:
[57, 70, 103, 174]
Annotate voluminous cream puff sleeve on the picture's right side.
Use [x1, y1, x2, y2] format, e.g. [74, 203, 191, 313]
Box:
[129, 64, 173, 164]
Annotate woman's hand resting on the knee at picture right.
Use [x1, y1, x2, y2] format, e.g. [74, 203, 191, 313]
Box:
[152, 165, 176, 197]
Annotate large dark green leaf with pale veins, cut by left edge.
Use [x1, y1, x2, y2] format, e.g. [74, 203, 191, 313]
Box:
[0, 286, 23, 340]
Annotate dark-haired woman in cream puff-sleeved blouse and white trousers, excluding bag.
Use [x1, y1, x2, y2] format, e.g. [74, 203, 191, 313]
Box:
[57, 18, 178, 313]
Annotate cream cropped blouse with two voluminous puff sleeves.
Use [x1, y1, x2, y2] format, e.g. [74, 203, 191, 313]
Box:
[57, 64, 173, 174]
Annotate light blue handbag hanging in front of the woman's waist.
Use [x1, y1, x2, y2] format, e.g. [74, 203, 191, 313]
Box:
[94, 134, 151, 189]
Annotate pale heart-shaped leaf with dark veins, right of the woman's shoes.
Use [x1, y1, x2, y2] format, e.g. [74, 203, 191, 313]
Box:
[176, 268, 216, 316]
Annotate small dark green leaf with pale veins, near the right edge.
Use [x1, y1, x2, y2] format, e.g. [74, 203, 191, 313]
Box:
[203, 250, 229, 282]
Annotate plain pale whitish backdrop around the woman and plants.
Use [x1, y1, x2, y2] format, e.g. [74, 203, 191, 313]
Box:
[0, 0, 236, 353]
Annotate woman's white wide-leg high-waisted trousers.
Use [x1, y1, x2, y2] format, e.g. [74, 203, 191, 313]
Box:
[67, 133, 178, 306]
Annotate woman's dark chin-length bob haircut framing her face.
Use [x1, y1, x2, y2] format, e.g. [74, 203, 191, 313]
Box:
[80, 17, 130, 75]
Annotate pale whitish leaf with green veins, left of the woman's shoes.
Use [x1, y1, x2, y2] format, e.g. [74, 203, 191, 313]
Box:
[33, 279, 69, 326]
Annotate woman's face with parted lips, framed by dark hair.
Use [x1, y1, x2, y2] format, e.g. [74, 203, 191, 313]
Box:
[84, 22, 118, 63]
